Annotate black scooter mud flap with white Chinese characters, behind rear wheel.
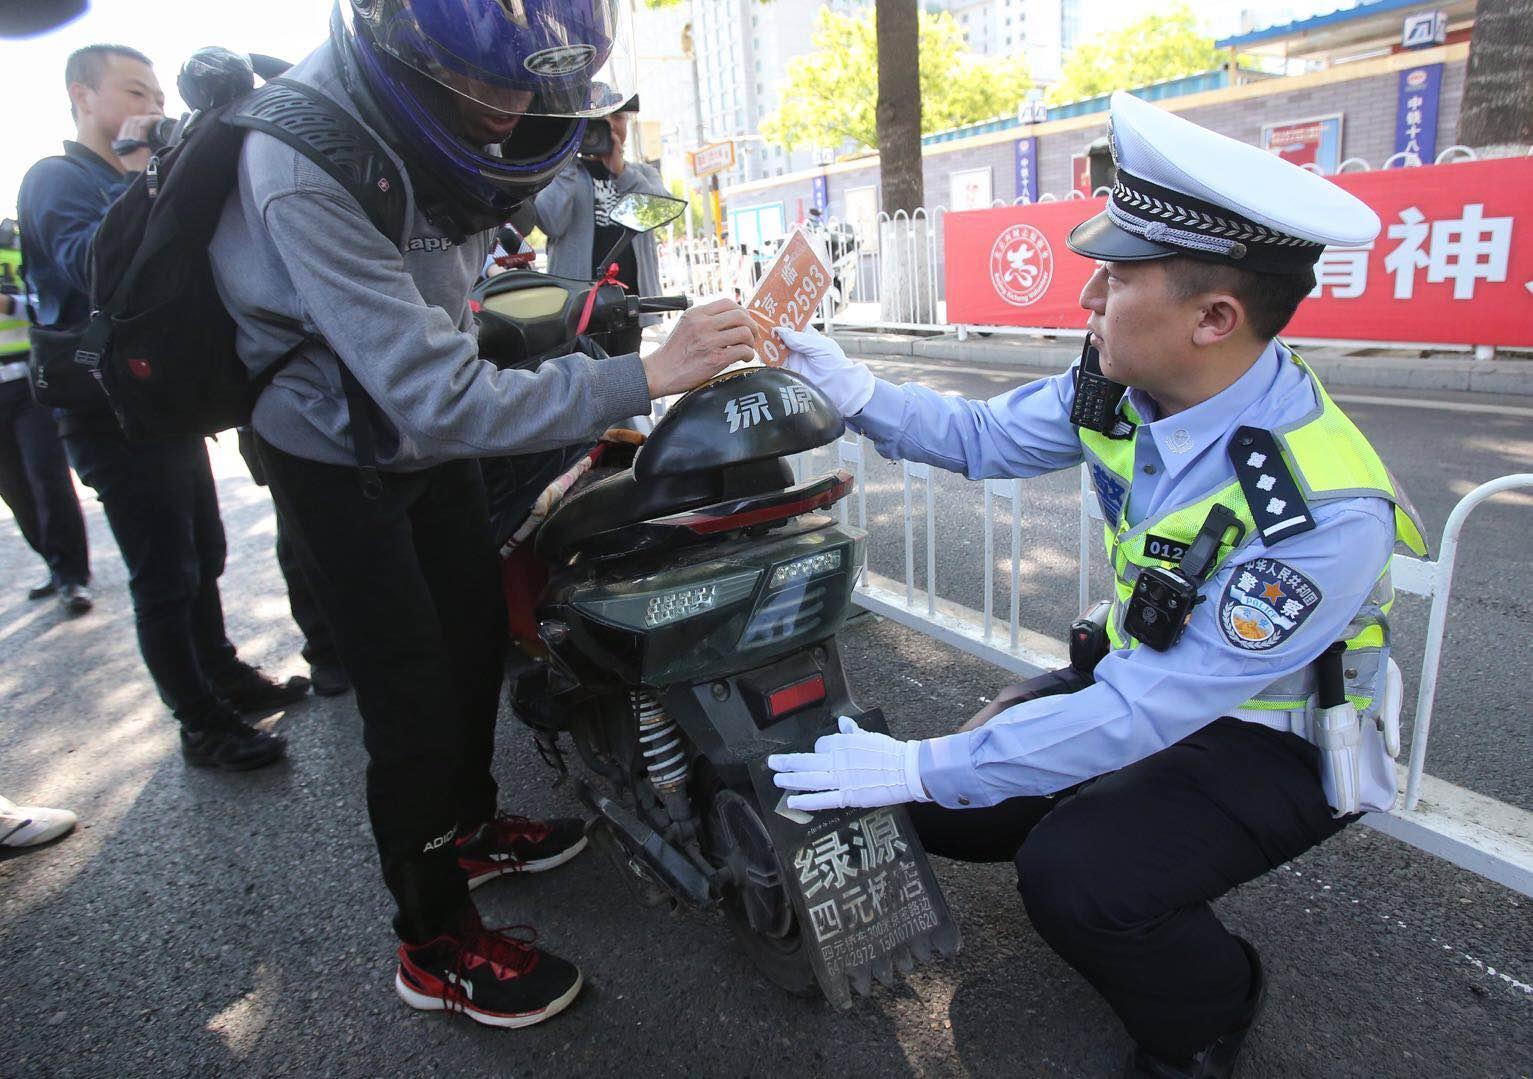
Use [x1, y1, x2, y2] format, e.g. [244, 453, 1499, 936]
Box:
[751, 710, 960, 1008]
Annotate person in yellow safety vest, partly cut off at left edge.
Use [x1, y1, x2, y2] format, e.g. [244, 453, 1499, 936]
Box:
[0, 219, 92, 615]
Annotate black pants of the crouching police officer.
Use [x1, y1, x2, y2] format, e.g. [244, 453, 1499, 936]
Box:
[911, 673, 1352, 1056]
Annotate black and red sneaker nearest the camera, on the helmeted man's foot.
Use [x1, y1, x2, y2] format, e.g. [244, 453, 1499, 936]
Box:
[394, 915, 583, 1027]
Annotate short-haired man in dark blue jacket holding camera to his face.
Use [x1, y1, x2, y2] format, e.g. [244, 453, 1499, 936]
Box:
[18, 44, 308, 771]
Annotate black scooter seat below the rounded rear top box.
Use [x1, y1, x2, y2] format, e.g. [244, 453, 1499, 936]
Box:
[533, 460, 793, 566]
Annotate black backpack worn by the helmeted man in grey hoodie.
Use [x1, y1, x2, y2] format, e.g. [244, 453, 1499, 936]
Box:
[80, 78, 405, 450]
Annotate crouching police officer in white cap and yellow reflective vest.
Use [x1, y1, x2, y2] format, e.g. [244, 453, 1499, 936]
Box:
[768, 93, 1426, 1077]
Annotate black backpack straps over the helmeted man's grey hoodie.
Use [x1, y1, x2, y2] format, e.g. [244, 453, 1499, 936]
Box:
[225, 78, 405, 500]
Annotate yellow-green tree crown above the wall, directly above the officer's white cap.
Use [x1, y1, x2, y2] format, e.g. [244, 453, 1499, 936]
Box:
[1049, 3, 1226, 104]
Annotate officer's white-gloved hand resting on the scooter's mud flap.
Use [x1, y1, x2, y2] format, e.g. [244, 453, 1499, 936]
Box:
[767, 716, 932, 812]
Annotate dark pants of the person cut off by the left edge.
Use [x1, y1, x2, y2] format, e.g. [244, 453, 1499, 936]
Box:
[0, 377, 90, 584]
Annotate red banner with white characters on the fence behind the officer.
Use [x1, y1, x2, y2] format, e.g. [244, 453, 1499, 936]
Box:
[944, 156, 1533, 348]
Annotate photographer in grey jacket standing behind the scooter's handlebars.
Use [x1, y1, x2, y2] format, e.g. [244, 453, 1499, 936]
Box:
[533, 97, 670, 356]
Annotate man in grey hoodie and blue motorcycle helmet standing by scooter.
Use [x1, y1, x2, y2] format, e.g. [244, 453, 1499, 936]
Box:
[212, 0, 751, 1027]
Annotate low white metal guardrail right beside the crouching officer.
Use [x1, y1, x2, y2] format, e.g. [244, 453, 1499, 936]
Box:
[794, 435, 1533, 897]
